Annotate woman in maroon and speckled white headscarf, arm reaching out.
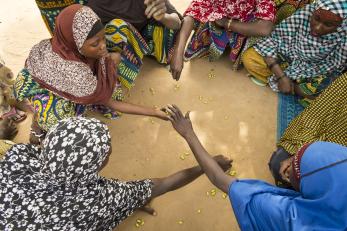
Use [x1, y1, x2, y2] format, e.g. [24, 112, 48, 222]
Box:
[15, 4, 173, 142]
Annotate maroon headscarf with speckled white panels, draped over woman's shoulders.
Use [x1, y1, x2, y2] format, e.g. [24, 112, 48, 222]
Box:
[26, 4, 117, 104]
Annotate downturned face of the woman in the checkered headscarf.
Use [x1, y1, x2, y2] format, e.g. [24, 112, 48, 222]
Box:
[310, 9, 342, 37]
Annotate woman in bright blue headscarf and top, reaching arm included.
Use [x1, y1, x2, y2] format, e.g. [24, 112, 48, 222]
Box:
[169, 107, 347, 231]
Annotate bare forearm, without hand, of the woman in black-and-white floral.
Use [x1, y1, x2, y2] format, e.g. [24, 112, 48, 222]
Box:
[152, 166, 204, 198]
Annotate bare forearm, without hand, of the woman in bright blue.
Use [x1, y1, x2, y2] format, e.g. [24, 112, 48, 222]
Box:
[185, 132, 234, 192]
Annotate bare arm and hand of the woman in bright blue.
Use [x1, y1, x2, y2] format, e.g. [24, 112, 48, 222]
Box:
[168, 105, 235, 193]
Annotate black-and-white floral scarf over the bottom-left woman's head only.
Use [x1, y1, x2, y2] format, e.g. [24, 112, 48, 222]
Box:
[41, 118, 111, 186]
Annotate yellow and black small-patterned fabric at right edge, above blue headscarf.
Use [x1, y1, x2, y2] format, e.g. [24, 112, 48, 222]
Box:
[278, 73, 347, 155]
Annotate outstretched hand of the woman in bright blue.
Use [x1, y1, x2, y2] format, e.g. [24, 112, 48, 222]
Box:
[165, 105, 194, 138]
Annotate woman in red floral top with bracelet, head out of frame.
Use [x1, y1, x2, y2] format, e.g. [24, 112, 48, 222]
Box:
[170, 0, 276, 80]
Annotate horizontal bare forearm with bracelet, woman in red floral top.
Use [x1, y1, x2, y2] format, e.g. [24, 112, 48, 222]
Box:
[228, 20, 274, 37]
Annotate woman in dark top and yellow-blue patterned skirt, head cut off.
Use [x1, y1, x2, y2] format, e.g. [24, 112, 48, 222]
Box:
[87, 0, 182, 88]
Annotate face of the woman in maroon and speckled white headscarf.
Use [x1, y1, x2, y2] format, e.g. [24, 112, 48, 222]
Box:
[81, 30, 108, 59]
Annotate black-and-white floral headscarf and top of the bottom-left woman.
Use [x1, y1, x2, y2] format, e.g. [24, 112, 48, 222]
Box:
[0, 118, 152, 231]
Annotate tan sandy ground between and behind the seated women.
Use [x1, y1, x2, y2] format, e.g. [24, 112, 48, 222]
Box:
[0, 0, 277, 231]
